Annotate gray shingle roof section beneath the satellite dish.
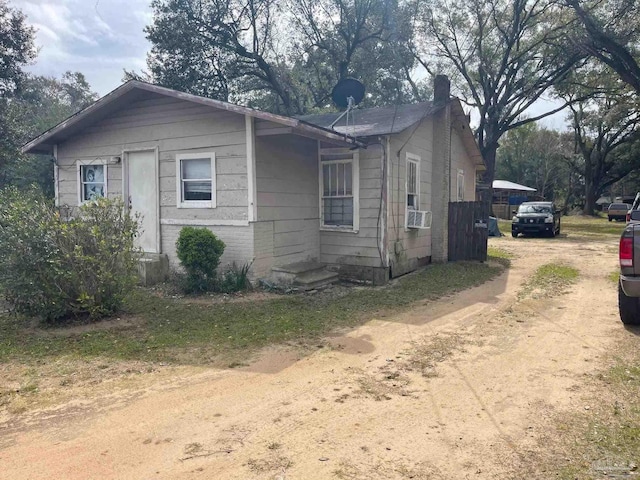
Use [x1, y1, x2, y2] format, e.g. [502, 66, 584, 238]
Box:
[296, 102, 441, 137]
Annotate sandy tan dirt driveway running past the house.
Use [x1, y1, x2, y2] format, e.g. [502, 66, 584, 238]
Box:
[0, 232, 629, 480]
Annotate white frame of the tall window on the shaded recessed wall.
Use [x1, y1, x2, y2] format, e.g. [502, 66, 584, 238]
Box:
[318, 147, 360, 233]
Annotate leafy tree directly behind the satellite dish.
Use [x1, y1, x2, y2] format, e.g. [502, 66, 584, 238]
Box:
[290, 0, 426, 107]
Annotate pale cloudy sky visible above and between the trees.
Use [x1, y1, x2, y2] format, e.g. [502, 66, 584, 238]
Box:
[15, 0, 565, 129]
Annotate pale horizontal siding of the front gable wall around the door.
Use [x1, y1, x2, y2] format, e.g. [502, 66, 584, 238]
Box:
[58, 92, 253, 263]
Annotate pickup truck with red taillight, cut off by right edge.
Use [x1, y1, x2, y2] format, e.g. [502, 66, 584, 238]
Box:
[618, 210, 640, 325]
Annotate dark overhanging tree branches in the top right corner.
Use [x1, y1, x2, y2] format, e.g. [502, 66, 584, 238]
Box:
[565, 0, 640, 94]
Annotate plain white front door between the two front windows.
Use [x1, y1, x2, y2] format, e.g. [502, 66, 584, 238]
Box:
[126, 150, 160, 253]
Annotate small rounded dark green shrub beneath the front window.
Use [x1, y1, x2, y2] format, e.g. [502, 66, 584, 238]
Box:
[176, 227, 225, 293]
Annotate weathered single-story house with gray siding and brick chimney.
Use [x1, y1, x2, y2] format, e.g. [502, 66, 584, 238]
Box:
[23, 77, 484, 284]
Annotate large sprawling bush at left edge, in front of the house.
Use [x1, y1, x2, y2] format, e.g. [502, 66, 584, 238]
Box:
[0, 189, 139, 322]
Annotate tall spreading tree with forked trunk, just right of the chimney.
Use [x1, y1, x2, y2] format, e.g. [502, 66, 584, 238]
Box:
[416, 0, 583, 201]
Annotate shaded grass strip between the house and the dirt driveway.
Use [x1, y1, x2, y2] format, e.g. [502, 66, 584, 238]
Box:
[0, 257, 508, 364]
